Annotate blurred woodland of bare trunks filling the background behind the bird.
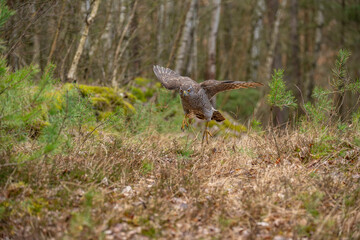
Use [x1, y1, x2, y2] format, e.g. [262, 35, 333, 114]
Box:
[0, 0, 360, 124]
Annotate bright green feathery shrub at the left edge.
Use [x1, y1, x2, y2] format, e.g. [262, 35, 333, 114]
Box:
[0, 59, 54, 151]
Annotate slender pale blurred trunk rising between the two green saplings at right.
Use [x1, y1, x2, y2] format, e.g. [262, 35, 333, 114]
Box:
[305, 1, 324, 101]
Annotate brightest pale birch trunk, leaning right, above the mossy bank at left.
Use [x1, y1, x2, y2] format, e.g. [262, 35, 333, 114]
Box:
[67, 0, 101, 81]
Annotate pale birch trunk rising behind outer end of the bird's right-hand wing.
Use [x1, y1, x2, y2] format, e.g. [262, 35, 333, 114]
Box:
[247, 0, 266, 81]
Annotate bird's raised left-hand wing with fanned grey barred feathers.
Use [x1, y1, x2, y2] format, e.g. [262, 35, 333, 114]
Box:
[153, 65, 197, 90]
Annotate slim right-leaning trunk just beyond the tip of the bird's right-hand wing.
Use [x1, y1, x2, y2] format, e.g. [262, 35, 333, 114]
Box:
[264, 0, 287, 81]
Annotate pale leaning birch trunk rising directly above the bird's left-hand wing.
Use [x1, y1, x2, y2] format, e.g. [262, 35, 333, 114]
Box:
[175, 0, 198, 74]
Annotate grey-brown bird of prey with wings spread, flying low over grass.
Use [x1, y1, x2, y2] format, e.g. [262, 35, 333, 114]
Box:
[153, 66, 263, 142]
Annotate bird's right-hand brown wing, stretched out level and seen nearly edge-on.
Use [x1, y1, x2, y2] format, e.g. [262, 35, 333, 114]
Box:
[200, 80, 264, 99]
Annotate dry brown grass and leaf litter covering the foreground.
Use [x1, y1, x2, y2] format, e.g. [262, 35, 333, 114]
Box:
[0, 127, 360, 239]
